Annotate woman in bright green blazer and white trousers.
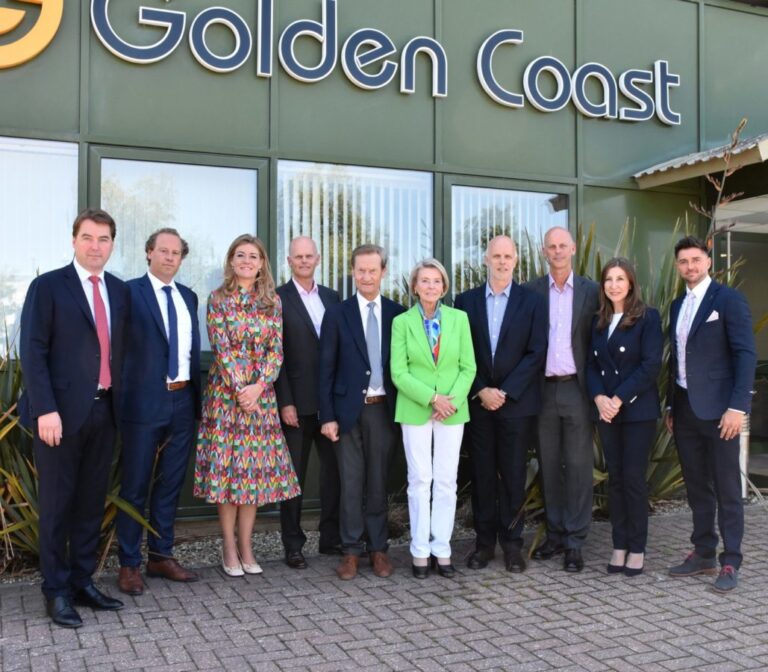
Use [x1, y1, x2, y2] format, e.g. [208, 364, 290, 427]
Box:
[390, 259, 476, 579]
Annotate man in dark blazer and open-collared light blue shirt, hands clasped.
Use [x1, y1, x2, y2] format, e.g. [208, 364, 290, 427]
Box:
[455, 236, 547, 572]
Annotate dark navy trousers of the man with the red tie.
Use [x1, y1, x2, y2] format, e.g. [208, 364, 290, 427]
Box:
[33, 396, 115, 599]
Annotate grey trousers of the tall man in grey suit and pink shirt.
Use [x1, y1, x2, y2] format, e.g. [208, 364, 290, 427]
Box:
[538, 379, 595, 548]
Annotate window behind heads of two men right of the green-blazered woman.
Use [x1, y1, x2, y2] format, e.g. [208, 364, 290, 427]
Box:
[451, 186, 568, 294]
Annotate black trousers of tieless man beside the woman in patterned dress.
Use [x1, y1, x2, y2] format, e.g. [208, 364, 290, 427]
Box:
[280, 414, 341, 551]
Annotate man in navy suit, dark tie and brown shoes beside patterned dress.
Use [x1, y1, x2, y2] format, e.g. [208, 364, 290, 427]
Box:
[117, 228, 200, 595]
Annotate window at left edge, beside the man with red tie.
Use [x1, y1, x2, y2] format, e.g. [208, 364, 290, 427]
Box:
[0, 137, 77, 354]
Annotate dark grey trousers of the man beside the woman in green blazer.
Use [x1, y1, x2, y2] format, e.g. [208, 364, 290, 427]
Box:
[335, 404, 397, 555]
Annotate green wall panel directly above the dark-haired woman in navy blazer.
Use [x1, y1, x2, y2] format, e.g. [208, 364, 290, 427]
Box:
[583, 187, 695, 279]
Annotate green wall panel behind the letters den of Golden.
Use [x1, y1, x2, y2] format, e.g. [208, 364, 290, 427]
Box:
[275, 0, 436, 165]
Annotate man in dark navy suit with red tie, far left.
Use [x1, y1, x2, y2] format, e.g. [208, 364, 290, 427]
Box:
[19, 209, 130, 628]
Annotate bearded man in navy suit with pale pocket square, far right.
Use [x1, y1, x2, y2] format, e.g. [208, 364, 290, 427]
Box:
[667, 236, 757, 592]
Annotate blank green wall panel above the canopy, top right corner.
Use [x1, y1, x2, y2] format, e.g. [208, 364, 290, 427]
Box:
[703, 7, 768, 147]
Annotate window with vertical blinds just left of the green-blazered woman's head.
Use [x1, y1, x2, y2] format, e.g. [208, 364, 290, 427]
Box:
[274, 161, 433, 303]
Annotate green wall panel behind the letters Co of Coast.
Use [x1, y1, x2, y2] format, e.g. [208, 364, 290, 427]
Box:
[439, 0, 576, 177]
